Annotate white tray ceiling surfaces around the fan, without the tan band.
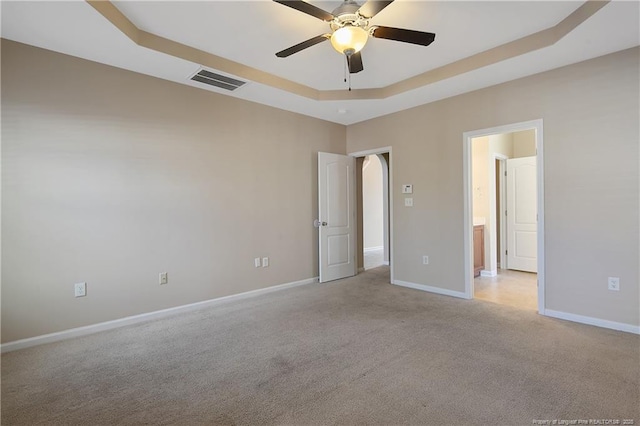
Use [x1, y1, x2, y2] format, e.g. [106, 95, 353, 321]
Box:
[0, 0, 640, 124]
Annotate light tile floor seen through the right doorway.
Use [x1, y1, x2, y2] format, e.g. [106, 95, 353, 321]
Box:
[474, 269, 538, 310]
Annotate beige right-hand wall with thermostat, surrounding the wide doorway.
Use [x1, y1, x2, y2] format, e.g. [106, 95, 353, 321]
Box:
[347, 48, 640, 325]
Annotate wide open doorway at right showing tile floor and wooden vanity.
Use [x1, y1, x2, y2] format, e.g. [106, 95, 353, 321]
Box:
[464, 121, 544, 313]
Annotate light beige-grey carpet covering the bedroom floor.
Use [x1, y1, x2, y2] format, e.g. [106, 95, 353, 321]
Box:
[2, 267, 640, 425]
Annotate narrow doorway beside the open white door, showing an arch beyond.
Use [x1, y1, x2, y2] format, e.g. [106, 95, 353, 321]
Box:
[350, 147, 393, 280]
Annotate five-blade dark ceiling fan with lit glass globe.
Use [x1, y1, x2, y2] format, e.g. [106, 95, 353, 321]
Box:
[273, 0, 436, 74]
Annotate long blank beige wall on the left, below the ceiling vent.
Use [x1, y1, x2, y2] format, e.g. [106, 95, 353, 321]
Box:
[2, 40, 346, 342]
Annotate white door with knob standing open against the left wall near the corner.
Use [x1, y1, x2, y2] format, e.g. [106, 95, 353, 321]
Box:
[316, 152, 356, 282]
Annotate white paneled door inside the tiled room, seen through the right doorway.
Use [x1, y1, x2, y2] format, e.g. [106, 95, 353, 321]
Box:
[507, 157, 538, 272]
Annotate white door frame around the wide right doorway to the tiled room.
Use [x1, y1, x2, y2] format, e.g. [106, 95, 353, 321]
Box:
[462, 119, 545, 315]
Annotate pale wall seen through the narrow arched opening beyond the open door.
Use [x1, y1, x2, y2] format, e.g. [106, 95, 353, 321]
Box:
[362, 155, 384, 250]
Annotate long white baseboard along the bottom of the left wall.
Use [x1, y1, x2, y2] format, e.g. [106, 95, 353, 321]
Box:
[0, 277, 318, 353]
